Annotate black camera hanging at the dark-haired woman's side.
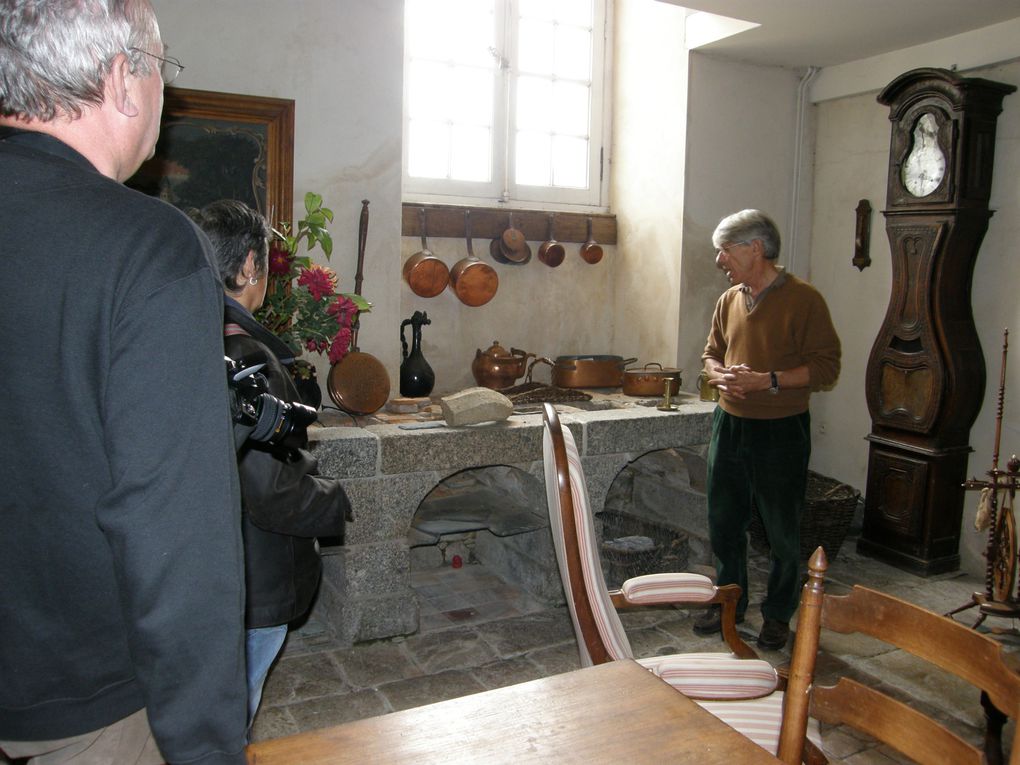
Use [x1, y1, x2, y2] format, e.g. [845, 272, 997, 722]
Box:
[223, 356, 318, 449]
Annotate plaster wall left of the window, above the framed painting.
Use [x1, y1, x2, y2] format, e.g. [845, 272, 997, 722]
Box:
[153, 0, 404, 387]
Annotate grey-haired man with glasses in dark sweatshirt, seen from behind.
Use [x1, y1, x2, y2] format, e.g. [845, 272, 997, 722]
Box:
[0, 0, 245, 765]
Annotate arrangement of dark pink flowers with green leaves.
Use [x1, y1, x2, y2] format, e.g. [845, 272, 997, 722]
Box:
[255, 192, 372, 364]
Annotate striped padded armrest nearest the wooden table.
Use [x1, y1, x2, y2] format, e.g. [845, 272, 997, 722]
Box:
[638, 653, 779, 700]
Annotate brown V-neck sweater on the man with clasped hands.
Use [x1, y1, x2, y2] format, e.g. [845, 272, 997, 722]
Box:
[702, 273, 839, 419]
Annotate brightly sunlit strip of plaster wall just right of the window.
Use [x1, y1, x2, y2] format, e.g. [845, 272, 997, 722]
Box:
[612, 0, 697, 375]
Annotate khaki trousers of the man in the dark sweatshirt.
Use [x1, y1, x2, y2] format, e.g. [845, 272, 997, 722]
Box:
[0, 709, 164, 765]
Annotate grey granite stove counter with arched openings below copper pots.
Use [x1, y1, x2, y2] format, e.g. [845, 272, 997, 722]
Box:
[312, 400, 714, 646]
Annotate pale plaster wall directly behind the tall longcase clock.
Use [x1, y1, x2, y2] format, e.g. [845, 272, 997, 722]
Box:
[811, 59, 1020, 574]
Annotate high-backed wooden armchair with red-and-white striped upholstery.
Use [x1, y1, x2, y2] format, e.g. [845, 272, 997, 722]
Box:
[544, 404, 795, 754]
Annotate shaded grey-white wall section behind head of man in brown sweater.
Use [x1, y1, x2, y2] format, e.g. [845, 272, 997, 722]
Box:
[678, 53, 810, 386]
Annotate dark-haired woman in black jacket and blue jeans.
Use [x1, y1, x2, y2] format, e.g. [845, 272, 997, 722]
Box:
[192, 200, 351, 734]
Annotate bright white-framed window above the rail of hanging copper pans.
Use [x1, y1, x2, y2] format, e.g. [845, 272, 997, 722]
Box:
[404, 0, 608, 208]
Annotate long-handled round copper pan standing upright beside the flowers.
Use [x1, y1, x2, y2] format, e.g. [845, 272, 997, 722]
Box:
[326, 199, 390, 415]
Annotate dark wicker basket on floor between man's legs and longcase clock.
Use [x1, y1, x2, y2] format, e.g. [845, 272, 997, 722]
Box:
[748, 470, 861, 560]
